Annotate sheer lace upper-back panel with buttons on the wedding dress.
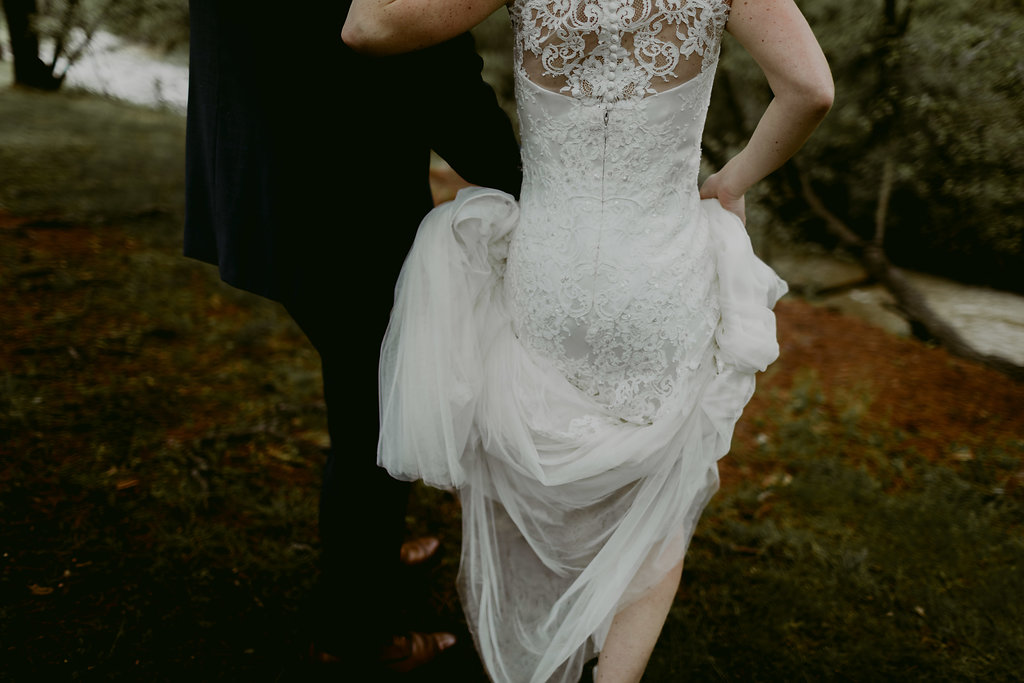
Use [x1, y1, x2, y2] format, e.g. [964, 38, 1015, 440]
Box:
[510, 0, 729, 101]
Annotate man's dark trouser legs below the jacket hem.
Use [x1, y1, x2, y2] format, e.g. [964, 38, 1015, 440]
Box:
[288, 296, 411, 659]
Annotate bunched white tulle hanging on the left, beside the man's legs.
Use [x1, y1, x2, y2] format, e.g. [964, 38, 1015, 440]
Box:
[377, 188, 518, 488]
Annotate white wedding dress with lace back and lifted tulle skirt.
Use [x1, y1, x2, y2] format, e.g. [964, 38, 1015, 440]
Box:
[379, 0, 785, 683]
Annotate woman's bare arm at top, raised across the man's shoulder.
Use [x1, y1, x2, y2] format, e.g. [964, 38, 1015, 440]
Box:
[341, 0, 505, 54]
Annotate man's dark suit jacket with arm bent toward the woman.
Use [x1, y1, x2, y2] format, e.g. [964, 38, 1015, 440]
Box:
[184, 0, 521, 305]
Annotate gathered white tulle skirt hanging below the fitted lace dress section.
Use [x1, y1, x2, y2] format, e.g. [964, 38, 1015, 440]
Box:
[378, 188, 785, 683]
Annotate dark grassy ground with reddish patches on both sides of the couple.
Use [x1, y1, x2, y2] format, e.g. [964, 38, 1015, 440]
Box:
[0, 78, 1024, 682]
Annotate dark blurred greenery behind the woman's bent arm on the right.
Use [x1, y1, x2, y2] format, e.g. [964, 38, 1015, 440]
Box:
[706, 0, 1024, 291]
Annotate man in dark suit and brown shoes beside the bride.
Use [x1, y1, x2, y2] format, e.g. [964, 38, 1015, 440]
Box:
[184, 0, 521, 680]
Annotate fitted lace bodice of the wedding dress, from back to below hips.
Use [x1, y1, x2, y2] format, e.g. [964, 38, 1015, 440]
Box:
[506, 0, 728, 423]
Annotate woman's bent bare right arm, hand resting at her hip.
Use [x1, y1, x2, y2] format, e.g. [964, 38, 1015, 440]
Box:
[700, 0, 835, 220]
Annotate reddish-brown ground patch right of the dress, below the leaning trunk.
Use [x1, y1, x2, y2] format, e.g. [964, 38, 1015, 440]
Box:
[721, 297, 1024, 485]
